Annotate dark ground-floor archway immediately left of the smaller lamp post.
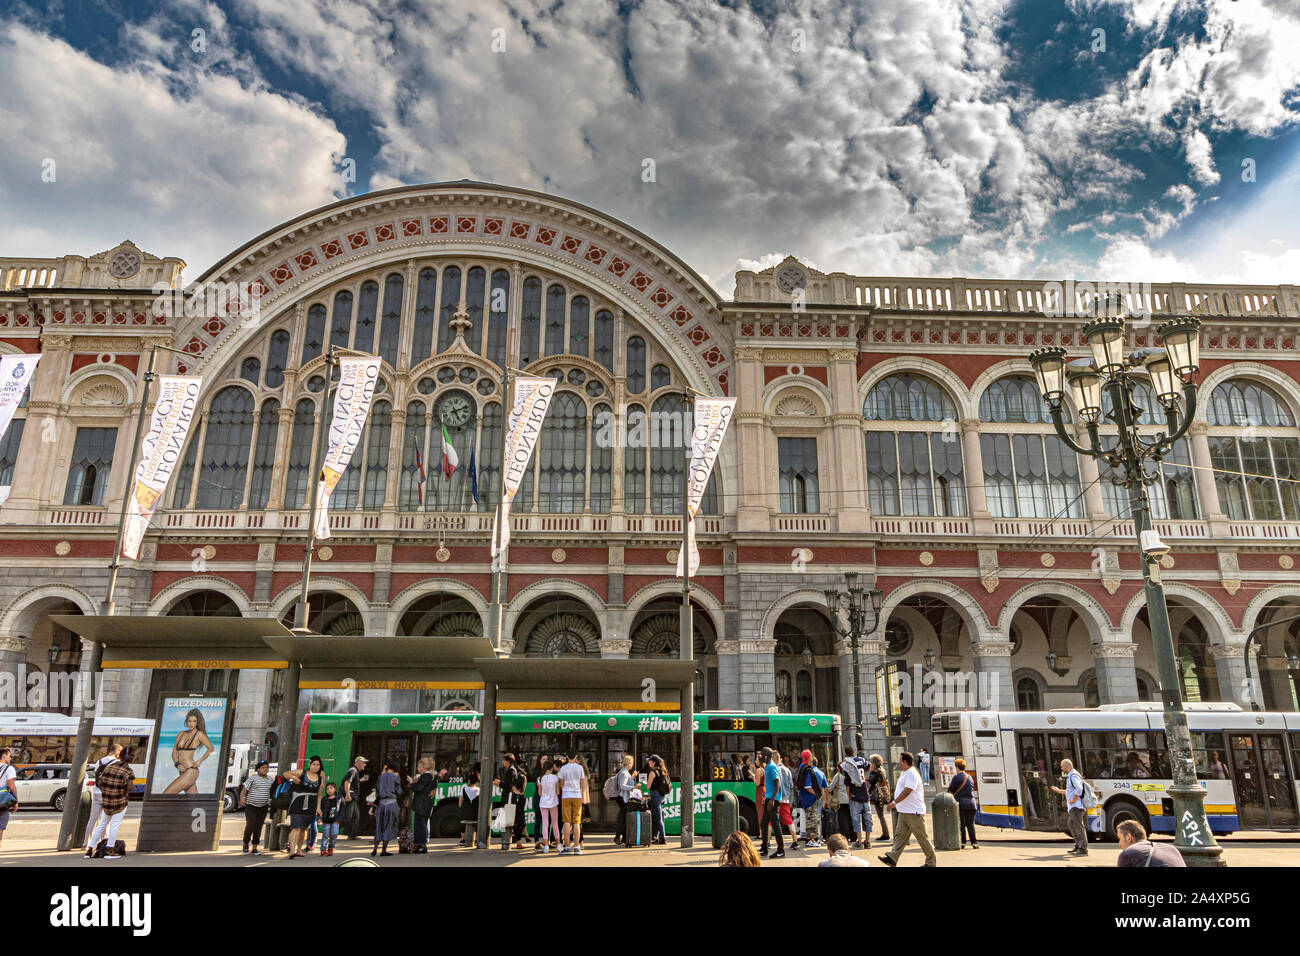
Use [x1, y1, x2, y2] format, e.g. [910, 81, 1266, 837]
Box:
[772, 604, 840, 714]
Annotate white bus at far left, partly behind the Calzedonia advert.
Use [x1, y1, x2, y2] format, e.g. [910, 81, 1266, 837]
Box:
[0, 710, 153, 795]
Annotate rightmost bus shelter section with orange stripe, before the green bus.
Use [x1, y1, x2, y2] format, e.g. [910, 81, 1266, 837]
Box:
[475, 656, 696, 847]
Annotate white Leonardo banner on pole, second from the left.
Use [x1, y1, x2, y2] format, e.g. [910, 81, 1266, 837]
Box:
[122, 375, 203, 558]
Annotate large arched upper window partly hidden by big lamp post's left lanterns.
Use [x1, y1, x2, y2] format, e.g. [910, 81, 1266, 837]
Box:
[979, 375, 1083, 518]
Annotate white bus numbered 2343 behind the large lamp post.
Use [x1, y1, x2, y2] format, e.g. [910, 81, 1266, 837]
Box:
[931, 702, 1300, 839]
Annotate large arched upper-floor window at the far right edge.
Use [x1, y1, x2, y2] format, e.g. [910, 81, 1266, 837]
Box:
[1206, 380, 1300, 522]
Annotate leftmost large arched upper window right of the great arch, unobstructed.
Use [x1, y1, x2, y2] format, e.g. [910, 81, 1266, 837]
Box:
[862, 375, 966, 515]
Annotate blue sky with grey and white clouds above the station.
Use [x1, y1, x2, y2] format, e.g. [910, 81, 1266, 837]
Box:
[0, 0, 1300, 294]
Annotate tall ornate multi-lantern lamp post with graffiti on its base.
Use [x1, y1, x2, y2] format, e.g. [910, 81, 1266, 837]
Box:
[1030, 312, 1223, 866]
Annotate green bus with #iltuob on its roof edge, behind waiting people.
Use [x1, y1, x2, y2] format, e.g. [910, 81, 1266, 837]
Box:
[298, 710, 841, 838]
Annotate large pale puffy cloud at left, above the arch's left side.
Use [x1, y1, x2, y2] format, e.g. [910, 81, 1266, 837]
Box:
[0, 22, 345, 273]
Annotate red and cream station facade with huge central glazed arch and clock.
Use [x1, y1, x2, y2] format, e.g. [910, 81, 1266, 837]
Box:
[0, 182, 1300, 740]
